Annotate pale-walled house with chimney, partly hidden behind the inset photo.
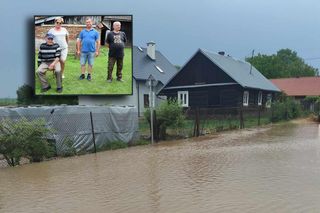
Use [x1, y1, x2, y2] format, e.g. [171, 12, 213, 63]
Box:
[79, 42, 177, 116]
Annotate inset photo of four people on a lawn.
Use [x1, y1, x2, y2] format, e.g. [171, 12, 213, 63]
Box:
[34, 15, 133, 95]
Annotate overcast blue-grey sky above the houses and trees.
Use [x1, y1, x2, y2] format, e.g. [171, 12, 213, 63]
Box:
[0, 0, 320, 98]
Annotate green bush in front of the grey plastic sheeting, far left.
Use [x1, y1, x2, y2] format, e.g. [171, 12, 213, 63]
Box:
[0, 118, 53, 166]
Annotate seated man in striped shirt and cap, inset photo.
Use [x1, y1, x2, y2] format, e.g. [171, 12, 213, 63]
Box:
[37, 33, 62, 93]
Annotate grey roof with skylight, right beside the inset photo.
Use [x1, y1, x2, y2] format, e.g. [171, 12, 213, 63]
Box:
[132, 46, 178, 84]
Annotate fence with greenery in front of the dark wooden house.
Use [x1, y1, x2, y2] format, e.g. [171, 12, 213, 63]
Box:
[144, 107, 273, 141]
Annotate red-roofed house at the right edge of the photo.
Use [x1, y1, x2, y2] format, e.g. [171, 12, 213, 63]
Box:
[270, 76, 320, 111]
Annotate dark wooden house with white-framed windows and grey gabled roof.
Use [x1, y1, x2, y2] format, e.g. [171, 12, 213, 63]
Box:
[159, 49, 280, 107]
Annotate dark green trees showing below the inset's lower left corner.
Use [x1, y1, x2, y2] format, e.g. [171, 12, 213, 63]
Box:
[17, 84, 78, 106]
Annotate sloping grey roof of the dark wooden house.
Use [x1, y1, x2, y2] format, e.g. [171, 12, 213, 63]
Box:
[199, 49, 280, 92]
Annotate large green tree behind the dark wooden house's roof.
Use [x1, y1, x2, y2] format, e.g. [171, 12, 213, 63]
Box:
[246, 49, 318, 79]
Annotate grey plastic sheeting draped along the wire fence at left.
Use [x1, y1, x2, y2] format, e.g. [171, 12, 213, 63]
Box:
[0, 106, 139, 154]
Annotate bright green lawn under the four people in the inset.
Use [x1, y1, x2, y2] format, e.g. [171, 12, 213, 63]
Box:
[35, 47, 132, 95]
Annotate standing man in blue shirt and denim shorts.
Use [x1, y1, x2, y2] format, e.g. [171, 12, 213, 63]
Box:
[77, 18, 100, 81]
